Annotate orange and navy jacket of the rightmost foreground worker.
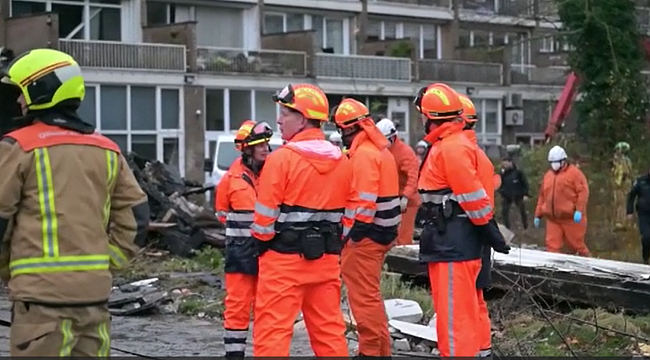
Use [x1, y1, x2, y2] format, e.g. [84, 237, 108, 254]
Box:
[418, 122, 502, 262]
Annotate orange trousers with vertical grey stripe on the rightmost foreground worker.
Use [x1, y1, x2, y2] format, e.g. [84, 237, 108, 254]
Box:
[429, 259, 481, 357]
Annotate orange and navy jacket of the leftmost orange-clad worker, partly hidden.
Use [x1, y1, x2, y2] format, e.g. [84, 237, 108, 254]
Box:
[215, 158, 257, 275]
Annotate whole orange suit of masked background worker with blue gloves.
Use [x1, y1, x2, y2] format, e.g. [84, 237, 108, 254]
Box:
[535, 164, 591, 256]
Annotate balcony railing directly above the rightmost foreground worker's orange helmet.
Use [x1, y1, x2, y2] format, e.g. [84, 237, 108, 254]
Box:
[418, 59, 503, 85]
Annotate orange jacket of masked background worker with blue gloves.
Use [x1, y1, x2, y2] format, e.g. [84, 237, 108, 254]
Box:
[535, 164, 589, 220]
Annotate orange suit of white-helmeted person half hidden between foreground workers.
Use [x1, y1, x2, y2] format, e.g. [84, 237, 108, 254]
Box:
[388, 137, 421, 245]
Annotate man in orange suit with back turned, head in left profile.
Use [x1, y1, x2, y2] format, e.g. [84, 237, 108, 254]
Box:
[251, 84, 351, 357]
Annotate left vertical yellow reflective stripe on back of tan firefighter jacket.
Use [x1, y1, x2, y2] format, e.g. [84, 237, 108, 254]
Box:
[34, 148, 59, 257]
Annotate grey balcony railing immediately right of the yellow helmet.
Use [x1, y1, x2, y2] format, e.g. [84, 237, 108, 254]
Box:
[59, 39, 187, 71]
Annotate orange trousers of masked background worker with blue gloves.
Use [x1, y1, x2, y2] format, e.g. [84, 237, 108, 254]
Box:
[546, 218, 591, 256]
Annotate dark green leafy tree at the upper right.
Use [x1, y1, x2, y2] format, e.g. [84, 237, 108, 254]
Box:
[555, 0, 648, 158]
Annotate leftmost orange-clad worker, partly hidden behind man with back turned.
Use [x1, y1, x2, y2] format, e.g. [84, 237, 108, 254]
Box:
[215, 120, 273, 358]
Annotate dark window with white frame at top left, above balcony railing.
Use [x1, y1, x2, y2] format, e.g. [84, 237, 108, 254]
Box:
[11, 0, 122, 41]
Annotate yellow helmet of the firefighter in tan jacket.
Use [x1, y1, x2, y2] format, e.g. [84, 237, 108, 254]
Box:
[0, 49, 86, 110]
